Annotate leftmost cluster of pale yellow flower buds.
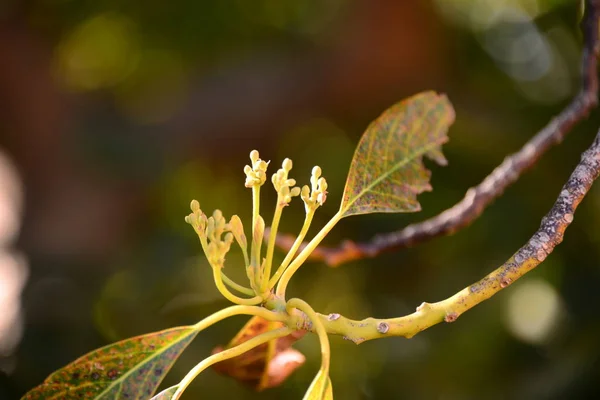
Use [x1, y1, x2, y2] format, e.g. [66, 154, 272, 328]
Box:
[185, 200, 234, 268]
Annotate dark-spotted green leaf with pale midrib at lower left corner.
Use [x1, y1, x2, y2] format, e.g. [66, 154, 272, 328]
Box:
[22, 326, 197, 400]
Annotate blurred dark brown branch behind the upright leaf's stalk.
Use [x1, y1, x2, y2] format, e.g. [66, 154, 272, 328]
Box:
[277, 0, 600, 266]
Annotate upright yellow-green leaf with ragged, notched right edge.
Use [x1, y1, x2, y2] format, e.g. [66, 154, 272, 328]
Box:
[340, 92, 454, 217]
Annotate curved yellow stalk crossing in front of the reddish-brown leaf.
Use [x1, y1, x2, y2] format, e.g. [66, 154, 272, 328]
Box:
[172, 328, 293, 399]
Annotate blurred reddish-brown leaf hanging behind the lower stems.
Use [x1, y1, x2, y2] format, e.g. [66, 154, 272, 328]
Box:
[213, 316, 306, 391]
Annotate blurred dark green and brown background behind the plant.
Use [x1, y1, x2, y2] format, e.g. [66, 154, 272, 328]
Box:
[0, 0, 600, 400]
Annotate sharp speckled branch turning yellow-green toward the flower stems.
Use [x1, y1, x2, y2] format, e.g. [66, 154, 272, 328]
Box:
[308, 122, 600, 344]
